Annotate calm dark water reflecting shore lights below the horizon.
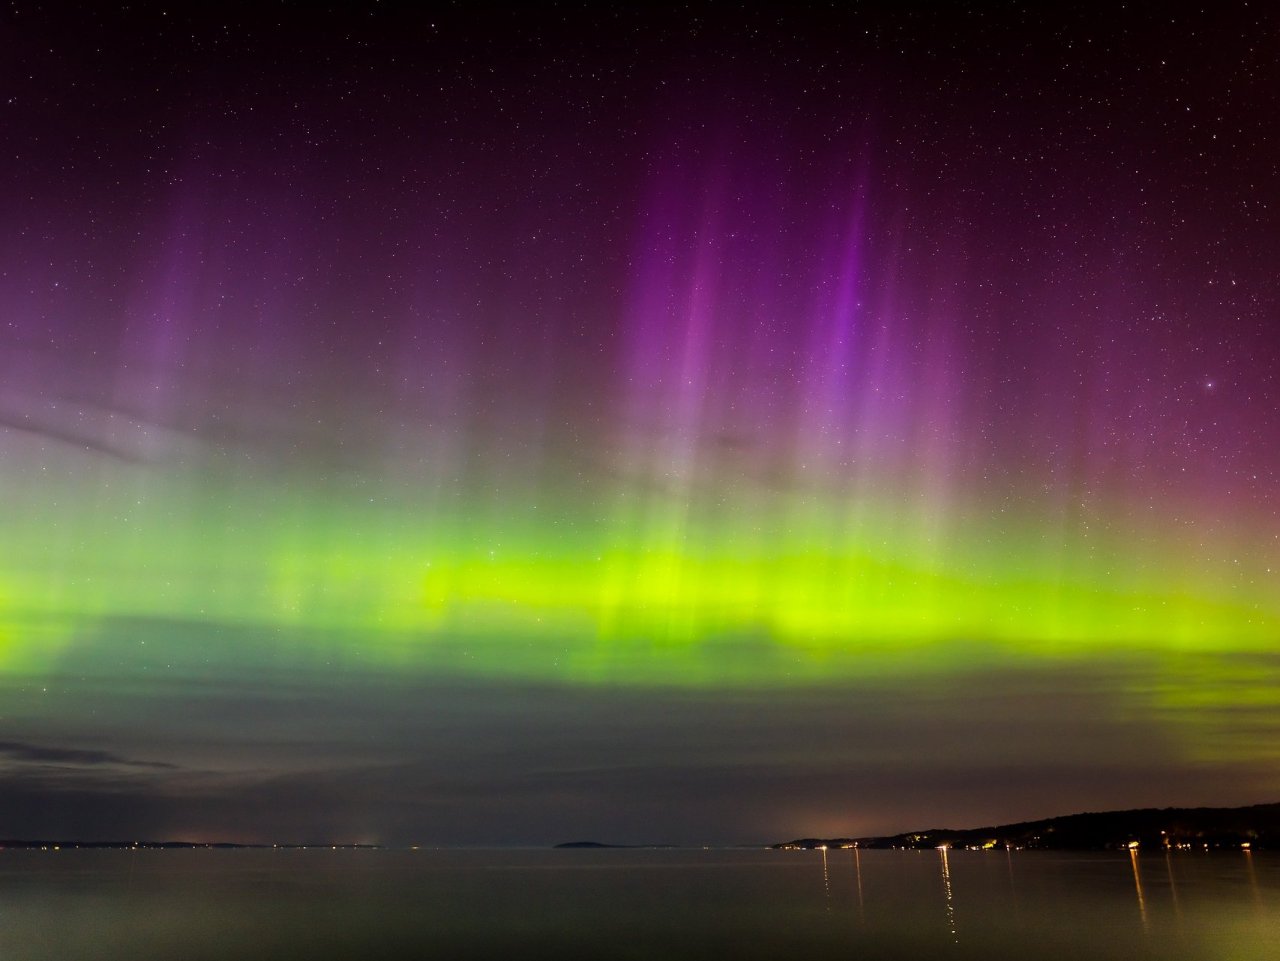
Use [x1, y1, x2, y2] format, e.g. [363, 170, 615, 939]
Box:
[0, 850, 1280, 961]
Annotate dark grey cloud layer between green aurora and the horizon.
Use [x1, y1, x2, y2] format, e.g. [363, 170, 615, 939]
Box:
[0, 624, 1267, 845]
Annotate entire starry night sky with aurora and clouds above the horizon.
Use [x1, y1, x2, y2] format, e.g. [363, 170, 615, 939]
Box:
[0, 0, 1280, 845]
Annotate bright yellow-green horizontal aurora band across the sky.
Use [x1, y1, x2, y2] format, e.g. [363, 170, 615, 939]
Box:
[0, 468, 1280, 686]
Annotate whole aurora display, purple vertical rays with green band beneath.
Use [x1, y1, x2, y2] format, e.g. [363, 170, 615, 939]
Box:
[0, 135, 1280, 683]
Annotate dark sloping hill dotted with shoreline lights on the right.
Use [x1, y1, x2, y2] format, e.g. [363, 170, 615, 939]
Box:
[773, 804, 1280, 851]
